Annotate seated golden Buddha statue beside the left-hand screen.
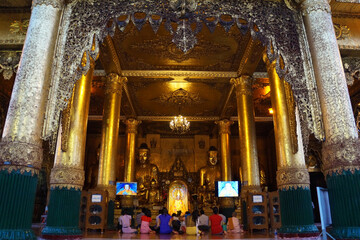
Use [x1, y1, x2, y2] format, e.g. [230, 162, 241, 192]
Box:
[135, 143, 159, 205]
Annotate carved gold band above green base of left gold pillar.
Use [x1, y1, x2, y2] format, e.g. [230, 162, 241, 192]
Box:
[50, 166, 85, 190]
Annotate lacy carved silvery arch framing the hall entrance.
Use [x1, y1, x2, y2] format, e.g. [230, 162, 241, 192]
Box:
[43, 0, 323, 146]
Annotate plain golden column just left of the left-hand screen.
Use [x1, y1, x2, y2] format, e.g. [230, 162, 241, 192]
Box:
[97, 73, 127, 200]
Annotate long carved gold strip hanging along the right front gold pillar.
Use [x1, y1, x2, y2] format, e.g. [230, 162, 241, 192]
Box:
[284, 81, 299, 154]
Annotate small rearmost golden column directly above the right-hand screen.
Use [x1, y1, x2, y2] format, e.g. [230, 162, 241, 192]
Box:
[216, 119, 233, 181]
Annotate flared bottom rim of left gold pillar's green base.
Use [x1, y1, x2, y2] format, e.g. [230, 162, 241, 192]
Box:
[41, 226, 82, 239]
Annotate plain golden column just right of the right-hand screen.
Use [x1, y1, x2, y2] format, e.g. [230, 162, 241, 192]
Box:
[230, 75, 261, 197]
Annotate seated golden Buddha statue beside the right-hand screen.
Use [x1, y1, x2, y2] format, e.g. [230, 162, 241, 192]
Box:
[199, 146, 221, 205]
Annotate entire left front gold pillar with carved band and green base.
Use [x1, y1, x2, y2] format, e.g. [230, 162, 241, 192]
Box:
[42, 54, 95, 238]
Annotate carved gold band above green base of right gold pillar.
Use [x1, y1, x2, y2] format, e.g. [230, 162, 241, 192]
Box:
[276, 166, 310, 190]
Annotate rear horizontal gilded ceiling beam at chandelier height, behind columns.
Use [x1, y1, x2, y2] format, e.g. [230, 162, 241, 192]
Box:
[88, 115, 273, 122]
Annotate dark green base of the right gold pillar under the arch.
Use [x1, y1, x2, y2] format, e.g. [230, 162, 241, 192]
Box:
[279, 187, 319, 234]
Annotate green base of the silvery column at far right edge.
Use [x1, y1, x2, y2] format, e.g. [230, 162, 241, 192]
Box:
[326, 170, 360, 239]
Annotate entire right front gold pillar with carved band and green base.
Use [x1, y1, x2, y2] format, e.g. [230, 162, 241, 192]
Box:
[264, 54, 318, 237]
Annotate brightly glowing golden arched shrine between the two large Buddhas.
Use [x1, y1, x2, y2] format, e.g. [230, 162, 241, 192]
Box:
[167, 180, 189, 214]
